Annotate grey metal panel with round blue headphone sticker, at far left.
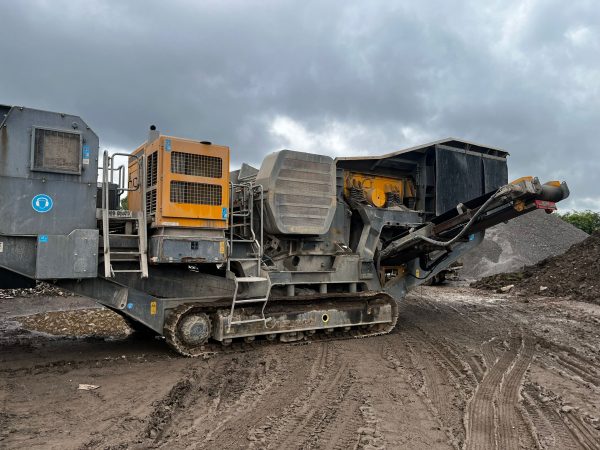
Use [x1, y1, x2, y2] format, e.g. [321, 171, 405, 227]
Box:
[0, 107, 98, 235]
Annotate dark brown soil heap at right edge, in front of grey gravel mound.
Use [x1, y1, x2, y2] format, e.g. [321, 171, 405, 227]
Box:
[471, 231, 600, 303]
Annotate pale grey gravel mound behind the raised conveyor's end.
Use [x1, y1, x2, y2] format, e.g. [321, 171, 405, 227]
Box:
[460, 210, 588, 280]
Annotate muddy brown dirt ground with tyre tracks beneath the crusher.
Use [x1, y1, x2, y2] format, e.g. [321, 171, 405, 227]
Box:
[0, 287, 600, 449]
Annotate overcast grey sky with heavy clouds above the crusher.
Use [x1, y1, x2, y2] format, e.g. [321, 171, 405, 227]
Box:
[0, 0, 600, 210]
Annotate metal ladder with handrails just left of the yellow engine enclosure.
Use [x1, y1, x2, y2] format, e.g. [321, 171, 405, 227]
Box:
[101, 150, 148, 278]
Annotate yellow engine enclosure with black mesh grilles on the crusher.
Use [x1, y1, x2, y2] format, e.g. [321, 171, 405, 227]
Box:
[128, 135, 229, 229]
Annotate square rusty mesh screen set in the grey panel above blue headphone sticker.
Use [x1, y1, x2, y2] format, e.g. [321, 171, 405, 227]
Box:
[33, 128, 81, 173]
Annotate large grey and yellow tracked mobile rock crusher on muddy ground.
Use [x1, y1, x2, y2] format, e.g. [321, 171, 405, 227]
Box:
[0, 107, 568, 355]
